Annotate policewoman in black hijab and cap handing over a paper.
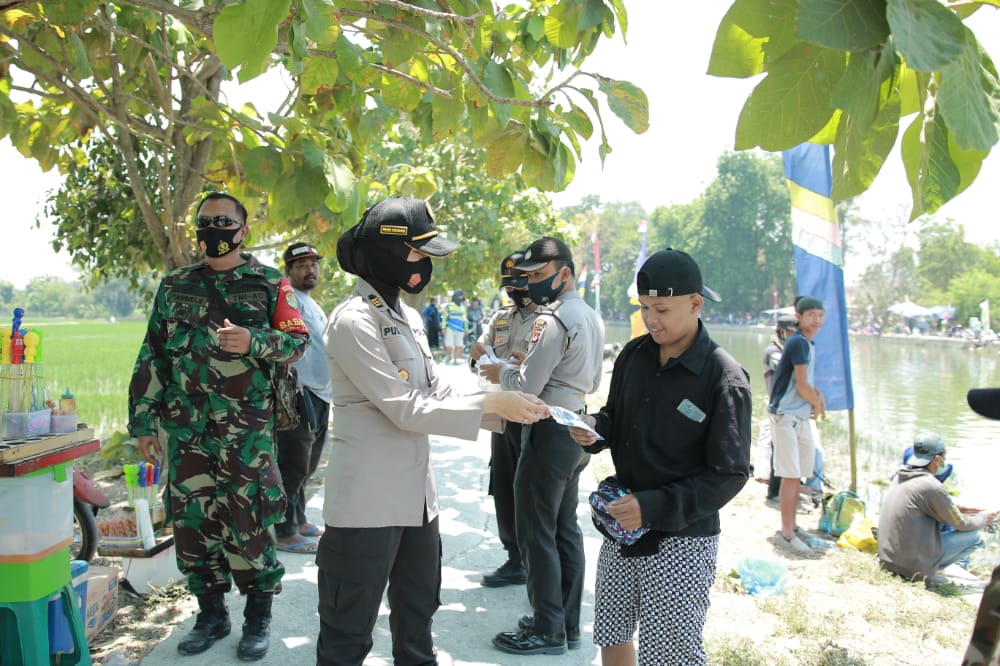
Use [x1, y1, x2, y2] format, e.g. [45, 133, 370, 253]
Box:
[316, 198, 548, 666]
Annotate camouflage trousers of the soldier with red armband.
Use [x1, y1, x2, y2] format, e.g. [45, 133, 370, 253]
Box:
[167, 421, 286, 594]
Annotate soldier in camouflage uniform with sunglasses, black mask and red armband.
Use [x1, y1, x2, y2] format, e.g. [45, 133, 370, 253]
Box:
[129, 193, 308, 661]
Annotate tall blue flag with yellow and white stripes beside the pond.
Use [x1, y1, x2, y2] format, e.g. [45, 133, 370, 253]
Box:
[783, 143, 854, 410]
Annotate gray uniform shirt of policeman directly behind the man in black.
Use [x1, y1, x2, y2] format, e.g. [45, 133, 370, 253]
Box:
[500, 290, 604, 412]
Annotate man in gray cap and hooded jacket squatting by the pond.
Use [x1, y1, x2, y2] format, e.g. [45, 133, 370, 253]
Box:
[878, 432, 996, 585]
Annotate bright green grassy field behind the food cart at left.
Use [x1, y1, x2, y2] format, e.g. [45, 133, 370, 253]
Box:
[24, 320, 146, 439]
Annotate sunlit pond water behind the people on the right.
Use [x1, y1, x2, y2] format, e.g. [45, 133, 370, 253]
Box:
[607, 323, 1000, 509]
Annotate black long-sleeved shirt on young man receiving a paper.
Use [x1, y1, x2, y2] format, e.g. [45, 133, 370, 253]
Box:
[587, 322, 752, 555]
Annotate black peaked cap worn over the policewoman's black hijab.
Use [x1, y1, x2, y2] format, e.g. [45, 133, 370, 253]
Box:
[357, 197, 458, 257]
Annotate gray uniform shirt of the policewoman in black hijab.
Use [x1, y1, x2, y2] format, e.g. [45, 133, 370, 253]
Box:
[323, 279, 500, 527]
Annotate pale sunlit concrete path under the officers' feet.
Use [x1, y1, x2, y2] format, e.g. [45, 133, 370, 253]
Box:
[142, 365, 601, 666]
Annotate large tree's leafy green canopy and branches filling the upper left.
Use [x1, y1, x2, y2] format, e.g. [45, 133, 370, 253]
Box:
[0, 0, 648, 282]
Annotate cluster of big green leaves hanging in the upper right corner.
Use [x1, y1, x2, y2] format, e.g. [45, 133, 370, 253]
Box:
[709, 0, 1000, 219]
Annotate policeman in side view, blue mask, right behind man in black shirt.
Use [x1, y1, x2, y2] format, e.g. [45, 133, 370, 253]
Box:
[484, 237, 604, 654]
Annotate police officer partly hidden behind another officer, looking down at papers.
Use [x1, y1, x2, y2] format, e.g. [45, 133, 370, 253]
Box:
[469, 250, 538, 587]
